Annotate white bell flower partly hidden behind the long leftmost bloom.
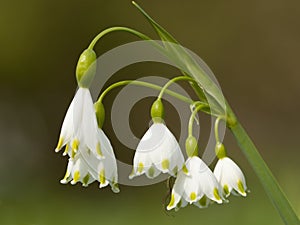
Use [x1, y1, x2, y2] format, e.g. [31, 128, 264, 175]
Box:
[61, 129, 119, 193]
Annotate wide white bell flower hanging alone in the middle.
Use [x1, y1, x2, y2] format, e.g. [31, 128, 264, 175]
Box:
[129, 123, 184, 179]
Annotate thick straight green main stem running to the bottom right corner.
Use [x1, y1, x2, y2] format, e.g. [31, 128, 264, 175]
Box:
[231, 118, 300, 225]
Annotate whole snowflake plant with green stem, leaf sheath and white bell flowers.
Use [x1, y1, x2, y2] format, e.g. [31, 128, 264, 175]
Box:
[55, 2, 300, 225]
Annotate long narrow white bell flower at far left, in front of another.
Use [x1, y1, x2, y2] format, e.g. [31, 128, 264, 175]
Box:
[55, 88, 102, 158]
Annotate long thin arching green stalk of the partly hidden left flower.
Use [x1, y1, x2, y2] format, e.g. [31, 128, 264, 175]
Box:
[98, 80, 194, 104]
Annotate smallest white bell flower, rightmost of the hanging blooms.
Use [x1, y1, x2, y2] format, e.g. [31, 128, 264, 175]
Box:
[214, 157, 247, 197]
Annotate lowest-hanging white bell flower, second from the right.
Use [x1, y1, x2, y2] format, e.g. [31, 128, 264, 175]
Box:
[167, 156, 222, 210]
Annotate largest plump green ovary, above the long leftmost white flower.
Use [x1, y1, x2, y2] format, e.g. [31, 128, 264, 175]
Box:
[76, 49, 97, 88]
